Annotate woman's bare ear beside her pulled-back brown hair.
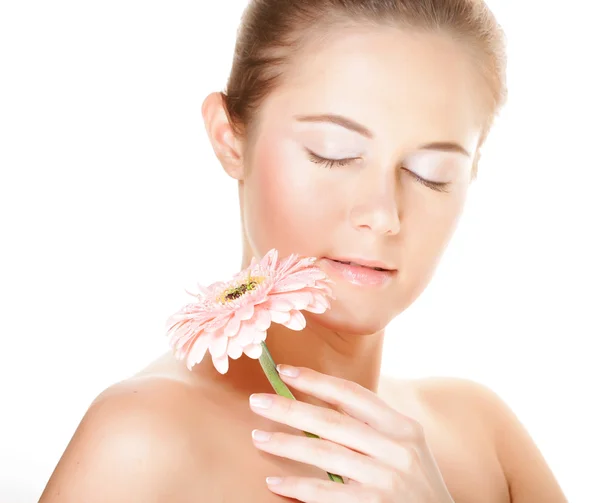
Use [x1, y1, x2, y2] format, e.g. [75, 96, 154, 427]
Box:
[202, 92, 244, 180]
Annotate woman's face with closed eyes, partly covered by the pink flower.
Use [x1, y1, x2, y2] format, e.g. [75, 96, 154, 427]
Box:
[241, 28, 483, 333]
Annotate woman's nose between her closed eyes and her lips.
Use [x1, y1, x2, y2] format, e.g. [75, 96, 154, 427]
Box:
[350, 171, 400, 235]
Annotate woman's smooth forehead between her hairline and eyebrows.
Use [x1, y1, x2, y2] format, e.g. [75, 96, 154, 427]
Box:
[261, 27, 482, 149]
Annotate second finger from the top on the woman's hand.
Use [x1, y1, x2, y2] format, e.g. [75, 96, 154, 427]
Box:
[251, 394, 409, 473]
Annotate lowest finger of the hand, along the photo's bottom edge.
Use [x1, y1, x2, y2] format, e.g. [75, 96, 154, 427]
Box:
[267, 477, 383, 503]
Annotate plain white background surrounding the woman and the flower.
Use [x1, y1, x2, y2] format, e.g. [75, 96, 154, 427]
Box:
[0, 0, 600, 503]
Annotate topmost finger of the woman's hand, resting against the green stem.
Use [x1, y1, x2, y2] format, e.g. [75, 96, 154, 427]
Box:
[278, 365, 423, 441]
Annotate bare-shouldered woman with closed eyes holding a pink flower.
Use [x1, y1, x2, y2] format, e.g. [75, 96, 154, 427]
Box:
[41, 0, 566, 503]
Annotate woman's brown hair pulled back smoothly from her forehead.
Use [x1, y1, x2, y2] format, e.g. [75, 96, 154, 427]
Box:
[223, 0, 506, 175]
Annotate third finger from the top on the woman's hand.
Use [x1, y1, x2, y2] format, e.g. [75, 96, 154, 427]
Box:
[252, 430, 394, 487]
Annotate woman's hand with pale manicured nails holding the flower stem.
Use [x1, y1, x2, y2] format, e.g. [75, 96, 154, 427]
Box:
[250, 365, 454, 503]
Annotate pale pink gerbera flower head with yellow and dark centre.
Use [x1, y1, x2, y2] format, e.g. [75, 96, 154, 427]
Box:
[167, 249, 333, 374]
